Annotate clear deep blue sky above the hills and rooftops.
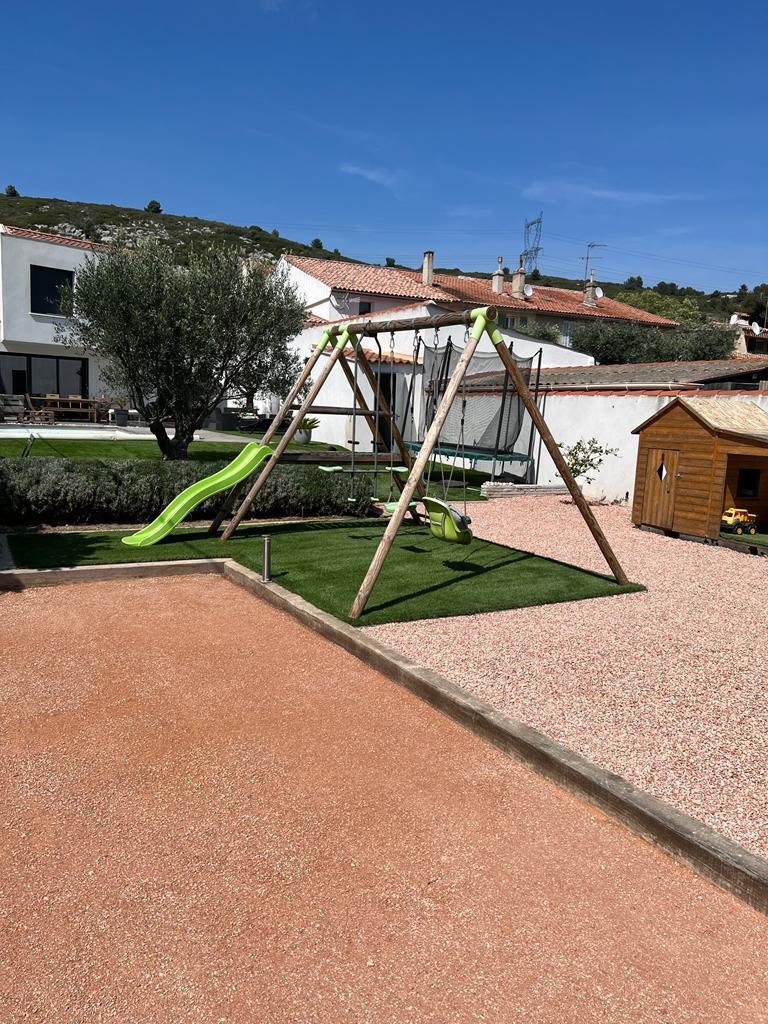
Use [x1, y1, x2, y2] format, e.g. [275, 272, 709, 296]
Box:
[0, 0, 768, 290]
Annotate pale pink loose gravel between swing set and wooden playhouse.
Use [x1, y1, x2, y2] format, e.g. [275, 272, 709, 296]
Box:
[367, 498, 768, 856]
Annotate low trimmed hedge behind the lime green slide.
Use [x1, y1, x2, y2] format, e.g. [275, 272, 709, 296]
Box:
[0, 458, 373, 526]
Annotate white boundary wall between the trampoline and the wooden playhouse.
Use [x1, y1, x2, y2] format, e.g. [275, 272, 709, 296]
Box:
[534, 391, 768, 501]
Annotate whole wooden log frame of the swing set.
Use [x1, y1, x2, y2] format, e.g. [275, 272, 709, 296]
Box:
[219, 306, 629, 618]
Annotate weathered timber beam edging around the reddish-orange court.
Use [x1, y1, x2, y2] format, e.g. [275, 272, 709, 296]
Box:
[0, 558, 768, 914]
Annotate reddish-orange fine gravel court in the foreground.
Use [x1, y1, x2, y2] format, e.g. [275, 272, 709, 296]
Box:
[0, 577, 768, 1024]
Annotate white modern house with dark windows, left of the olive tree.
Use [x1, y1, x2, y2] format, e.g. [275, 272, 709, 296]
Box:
[0, 224, 105, 397]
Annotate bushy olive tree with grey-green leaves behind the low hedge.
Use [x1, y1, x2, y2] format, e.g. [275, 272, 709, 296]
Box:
[59, 239, 305, 459]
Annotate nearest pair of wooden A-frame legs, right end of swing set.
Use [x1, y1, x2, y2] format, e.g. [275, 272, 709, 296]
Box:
[349, 306, 629, 618]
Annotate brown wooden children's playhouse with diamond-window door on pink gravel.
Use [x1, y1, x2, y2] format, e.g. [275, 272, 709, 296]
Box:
[632, 395, 768, 539]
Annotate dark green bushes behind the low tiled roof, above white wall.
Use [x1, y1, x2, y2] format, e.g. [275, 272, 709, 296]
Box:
[573, 321, 734, 364]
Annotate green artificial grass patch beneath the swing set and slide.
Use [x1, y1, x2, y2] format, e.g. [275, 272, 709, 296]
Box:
[8, 519, 644, 626]
